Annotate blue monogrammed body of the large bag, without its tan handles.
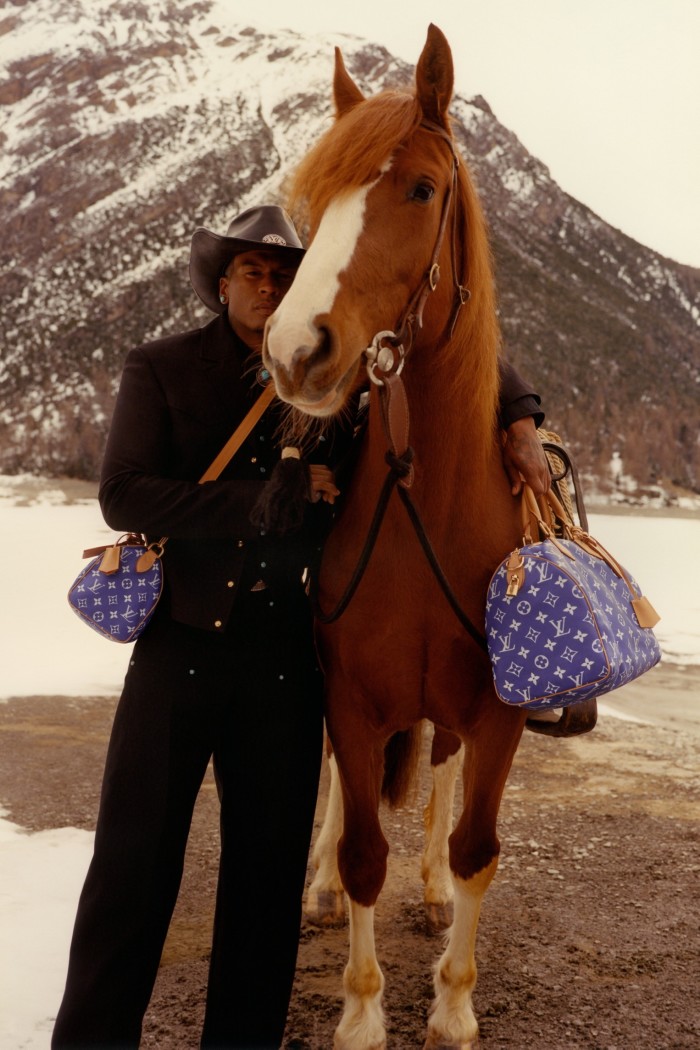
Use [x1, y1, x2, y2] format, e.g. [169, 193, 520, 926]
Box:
[486, 540, 661, 711]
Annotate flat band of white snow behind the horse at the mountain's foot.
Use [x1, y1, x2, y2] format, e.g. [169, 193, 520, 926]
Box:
[0, 477, 700, 705]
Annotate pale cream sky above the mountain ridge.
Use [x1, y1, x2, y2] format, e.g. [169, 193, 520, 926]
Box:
[251, 0, 700, 267]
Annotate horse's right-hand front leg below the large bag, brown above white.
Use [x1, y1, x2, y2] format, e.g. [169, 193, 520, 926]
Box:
[424, 705, 525, 1050]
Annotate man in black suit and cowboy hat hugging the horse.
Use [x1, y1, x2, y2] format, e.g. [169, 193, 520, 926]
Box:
[52, 207, 538, 1050]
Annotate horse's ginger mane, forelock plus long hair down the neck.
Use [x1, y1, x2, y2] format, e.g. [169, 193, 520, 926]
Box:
[289, 81, 501, 452]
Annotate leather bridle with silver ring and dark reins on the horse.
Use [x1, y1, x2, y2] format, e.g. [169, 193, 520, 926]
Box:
[311, 121, 487, 652]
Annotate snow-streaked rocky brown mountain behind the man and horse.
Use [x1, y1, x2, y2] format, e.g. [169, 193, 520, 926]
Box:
[0, 0, 700, 494]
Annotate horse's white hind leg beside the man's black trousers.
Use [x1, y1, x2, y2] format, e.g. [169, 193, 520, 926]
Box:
[305, 753, 345, 926]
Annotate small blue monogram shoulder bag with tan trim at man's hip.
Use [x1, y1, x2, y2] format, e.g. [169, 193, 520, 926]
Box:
[68, 533, 163, 642]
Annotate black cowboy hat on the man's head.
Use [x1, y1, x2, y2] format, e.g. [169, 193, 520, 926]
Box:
[190, 205, 304, 314]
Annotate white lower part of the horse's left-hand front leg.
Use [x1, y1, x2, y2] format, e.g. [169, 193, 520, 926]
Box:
[333, 901, 386, 1050]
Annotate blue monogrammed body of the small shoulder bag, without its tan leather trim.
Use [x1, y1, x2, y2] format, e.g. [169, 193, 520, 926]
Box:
[68, 544, 163, 642]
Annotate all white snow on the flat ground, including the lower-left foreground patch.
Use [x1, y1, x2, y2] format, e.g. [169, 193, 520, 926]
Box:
[0, 478, 700, 1050]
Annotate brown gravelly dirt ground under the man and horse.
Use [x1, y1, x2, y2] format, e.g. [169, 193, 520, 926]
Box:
[0, 667, 700, 1050]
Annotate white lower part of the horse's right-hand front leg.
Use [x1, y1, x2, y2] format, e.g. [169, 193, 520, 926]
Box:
[426, 858, 499, 1048]
